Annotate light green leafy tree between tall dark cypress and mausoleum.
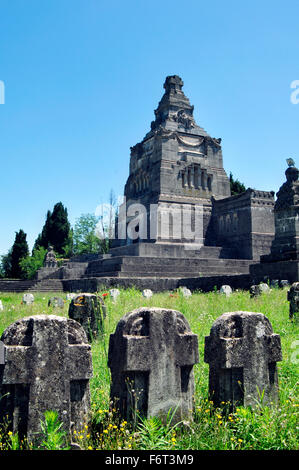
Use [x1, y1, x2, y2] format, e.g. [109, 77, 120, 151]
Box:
[73, 214, 101, 255]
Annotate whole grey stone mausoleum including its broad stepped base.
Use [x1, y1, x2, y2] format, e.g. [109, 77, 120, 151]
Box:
[2, 75, 298, 292]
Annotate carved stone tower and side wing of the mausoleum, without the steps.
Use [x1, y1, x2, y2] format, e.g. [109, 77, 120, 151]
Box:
[111, 75, 274, 260]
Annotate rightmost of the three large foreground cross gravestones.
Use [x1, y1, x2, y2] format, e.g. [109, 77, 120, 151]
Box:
[204, 312, 282, 407]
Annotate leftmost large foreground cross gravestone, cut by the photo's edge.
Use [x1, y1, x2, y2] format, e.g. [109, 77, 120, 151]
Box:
[0, 315, 92, 443]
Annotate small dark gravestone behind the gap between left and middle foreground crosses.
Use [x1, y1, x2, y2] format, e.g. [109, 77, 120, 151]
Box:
[69, 293, 106, 341]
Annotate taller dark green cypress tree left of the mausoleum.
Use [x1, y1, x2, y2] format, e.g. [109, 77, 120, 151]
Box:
[33, 202, 72, 256]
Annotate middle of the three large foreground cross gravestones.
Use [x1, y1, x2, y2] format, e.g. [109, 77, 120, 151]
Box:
[108, 308, 198, 422]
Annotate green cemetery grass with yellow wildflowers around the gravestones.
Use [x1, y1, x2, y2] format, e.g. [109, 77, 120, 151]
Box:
[0, 288, 299, 450]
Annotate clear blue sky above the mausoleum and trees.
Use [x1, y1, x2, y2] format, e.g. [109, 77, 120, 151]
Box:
[0, 0, 299, 254]
